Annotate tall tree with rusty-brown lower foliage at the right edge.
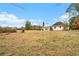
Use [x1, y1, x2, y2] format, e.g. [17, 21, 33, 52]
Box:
[66, 3, 79, 29]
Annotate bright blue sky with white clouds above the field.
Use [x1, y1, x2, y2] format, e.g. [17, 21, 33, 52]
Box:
[0, 3, 70, 27]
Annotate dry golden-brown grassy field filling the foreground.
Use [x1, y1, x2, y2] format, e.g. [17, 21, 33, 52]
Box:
[0, 31, 79, 56]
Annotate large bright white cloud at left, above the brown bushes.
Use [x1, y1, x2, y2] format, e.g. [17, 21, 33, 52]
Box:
[0, 12, 25, 27]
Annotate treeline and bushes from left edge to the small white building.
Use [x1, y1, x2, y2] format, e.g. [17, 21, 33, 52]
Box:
[0, 21, 42, 33]
